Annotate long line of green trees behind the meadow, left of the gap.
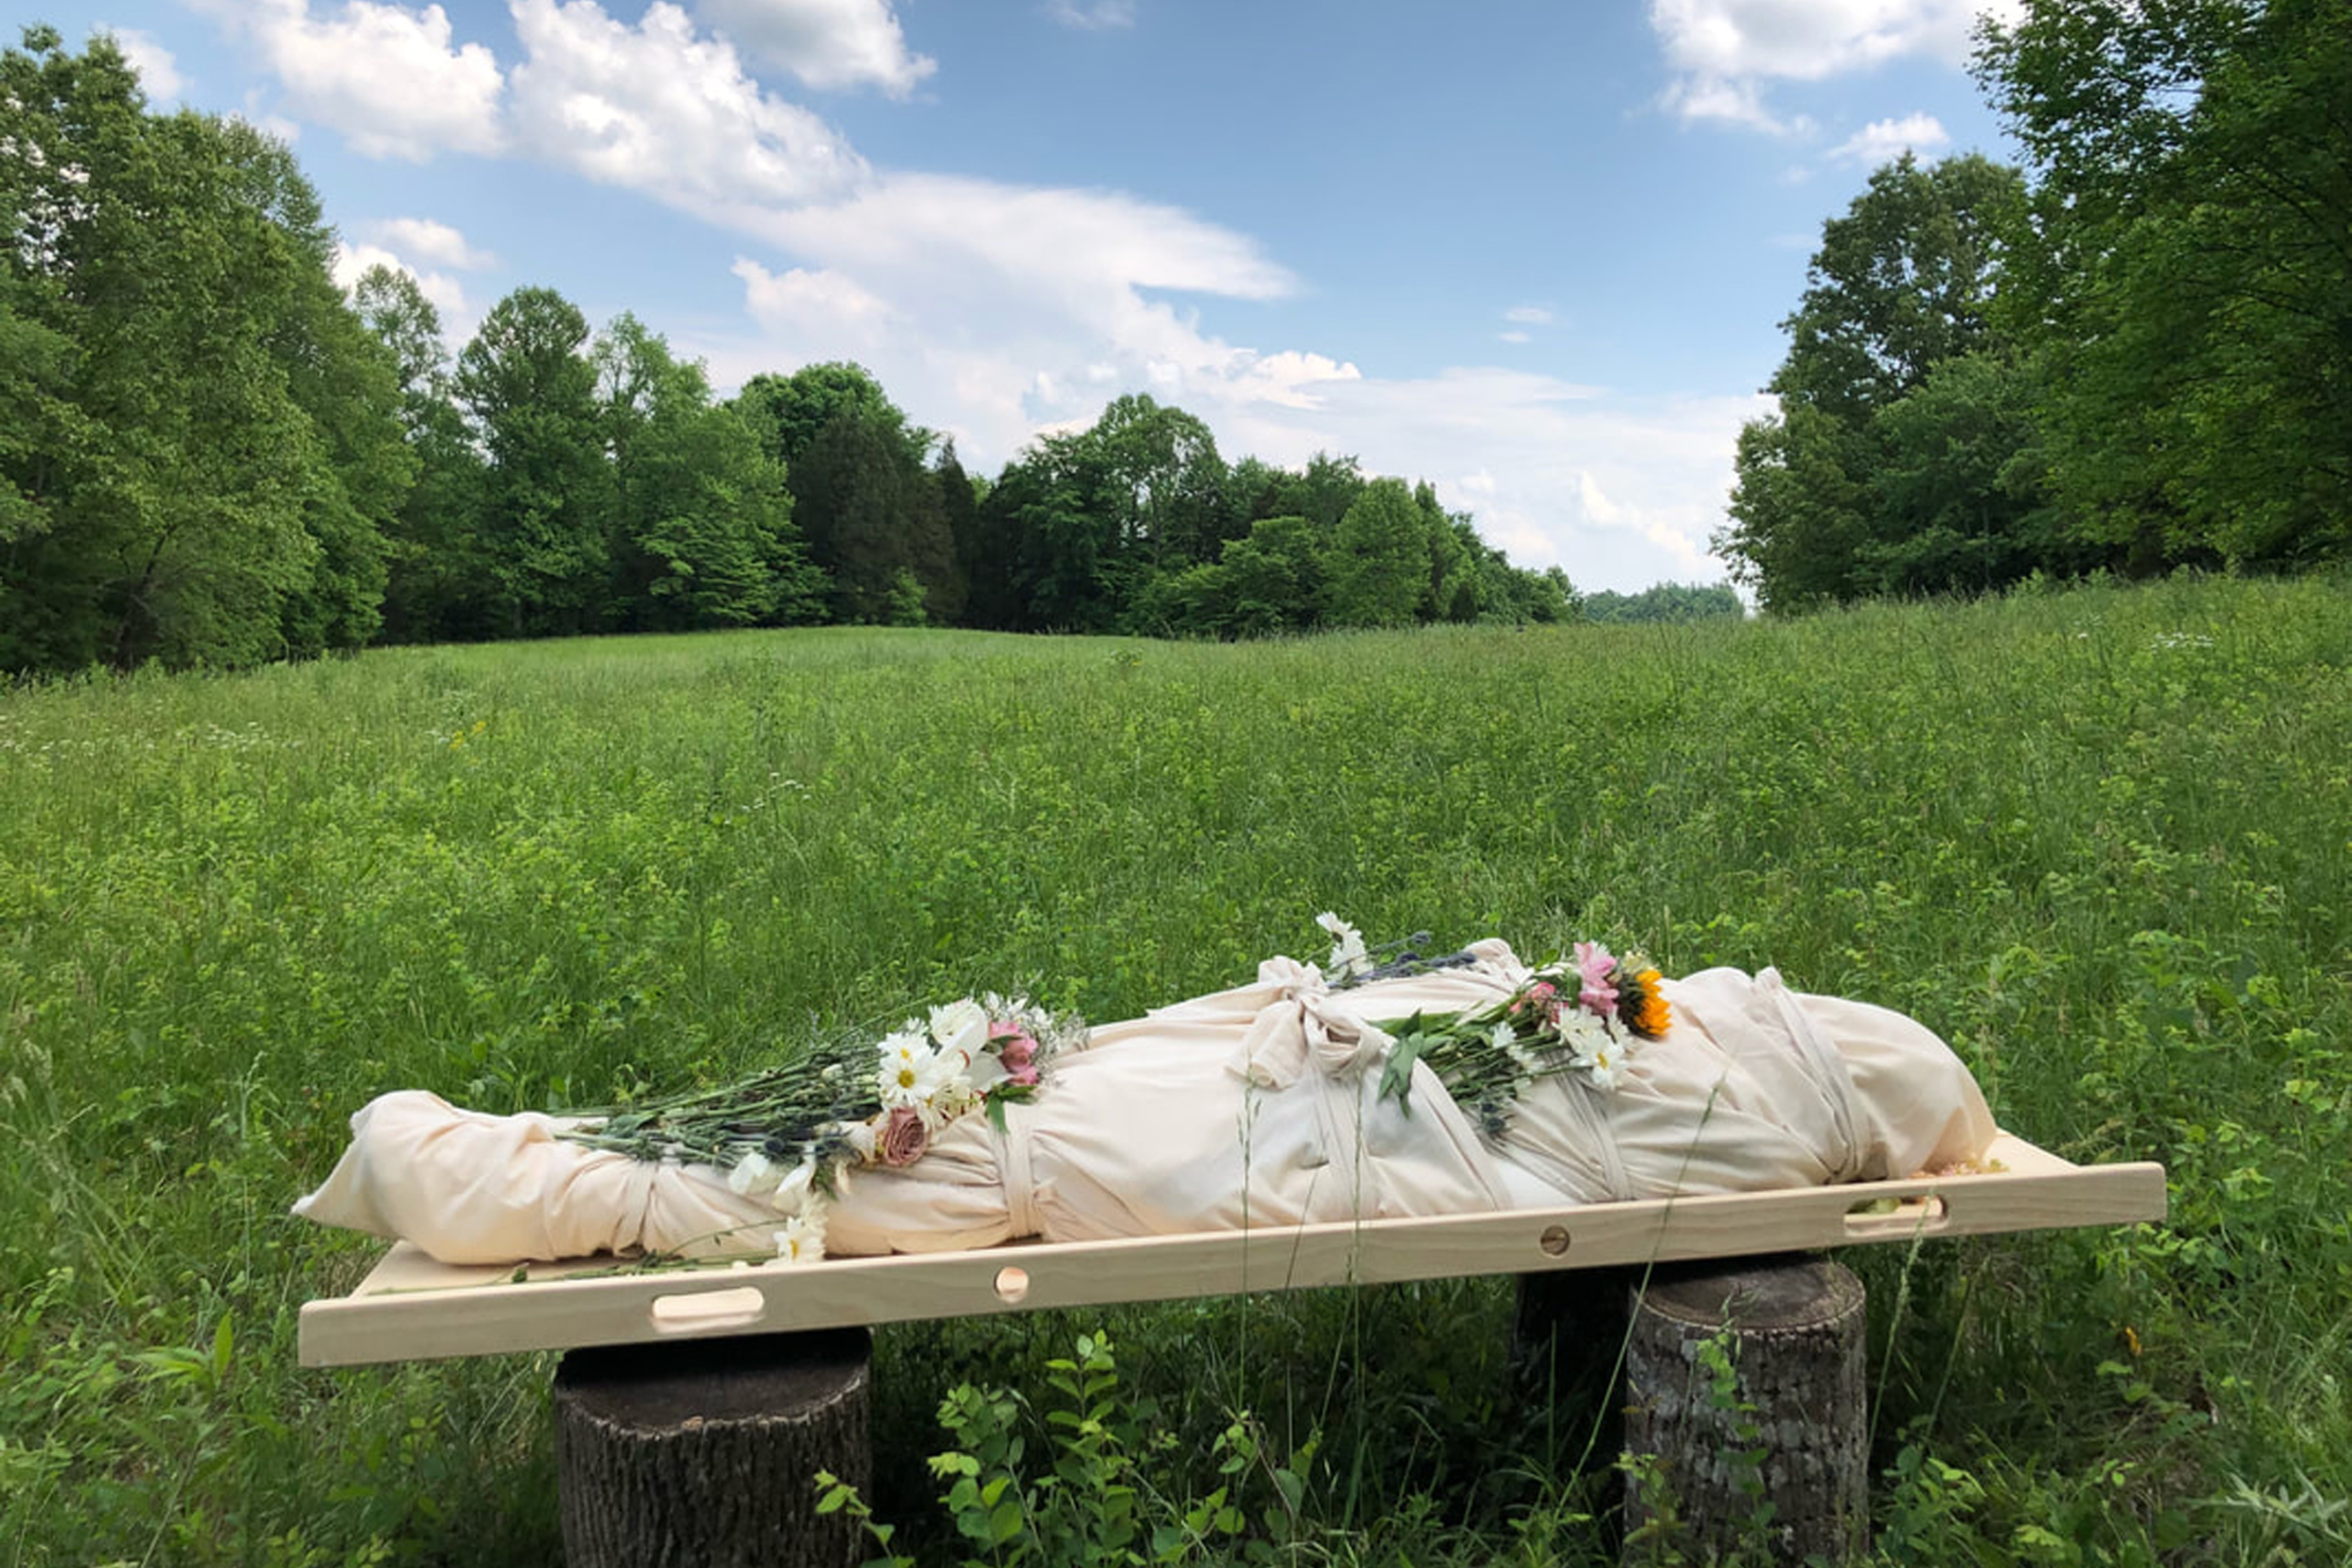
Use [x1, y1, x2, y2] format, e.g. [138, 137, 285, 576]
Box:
[0, 26, 1608, 672]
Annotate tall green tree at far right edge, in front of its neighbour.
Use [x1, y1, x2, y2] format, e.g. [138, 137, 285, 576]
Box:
[1978, 0, 2352, 566]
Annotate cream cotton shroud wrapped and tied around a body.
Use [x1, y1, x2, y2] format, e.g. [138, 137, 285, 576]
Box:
[294, 940, 1995, 1262]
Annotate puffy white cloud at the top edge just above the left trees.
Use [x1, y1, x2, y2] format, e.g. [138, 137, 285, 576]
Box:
[196, 0, 503, 160]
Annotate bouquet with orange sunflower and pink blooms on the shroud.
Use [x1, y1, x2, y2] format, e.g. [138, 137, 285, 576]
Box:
[1381, 943, 1670, 1137]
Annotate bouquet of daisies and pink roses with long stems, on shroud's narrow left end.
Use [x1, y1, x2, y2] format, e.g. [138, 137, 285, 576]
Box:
[562, 992, 1087, 1262]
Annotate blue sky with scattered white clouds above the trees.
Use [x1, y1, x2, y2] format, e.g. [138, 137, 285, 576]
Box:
[45, 0, 2009, 590]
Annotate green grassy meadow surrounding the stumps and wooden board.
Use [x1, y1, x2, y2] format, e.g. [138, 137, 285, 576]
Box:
[0, 580, 2352, 1568]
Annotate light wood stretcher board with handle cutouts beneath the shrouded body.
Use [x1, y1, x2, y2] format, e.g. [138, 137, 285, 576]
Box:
[301, 1133, 2164, 1366]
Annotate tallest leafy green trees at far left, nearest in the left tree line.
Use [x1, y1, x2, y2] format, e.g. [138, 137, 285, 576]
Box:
[0, 28, 411, 670]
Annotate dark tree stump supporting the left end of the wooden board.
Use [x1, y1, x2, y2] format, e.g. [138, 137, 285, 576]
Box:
[555, 1328, 873, 1568]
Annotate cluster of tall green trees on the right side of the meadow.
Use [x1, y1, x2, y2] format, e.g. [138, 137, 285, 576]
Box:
[1715, 0, 2352, 609]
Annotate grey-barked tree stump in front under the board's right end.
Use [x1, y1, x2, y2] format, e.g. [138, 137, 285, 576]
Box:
[1625, 1258, 1870, 1563]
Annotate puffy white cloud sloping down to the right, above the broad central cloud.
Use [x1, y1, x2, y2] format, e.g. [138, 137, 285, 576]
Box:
[513, 0, 866, 217]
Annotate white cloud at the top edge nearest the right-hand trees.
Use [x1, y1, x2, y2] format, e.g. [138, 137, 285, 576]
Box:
[1649, 0, 2022, 134]
